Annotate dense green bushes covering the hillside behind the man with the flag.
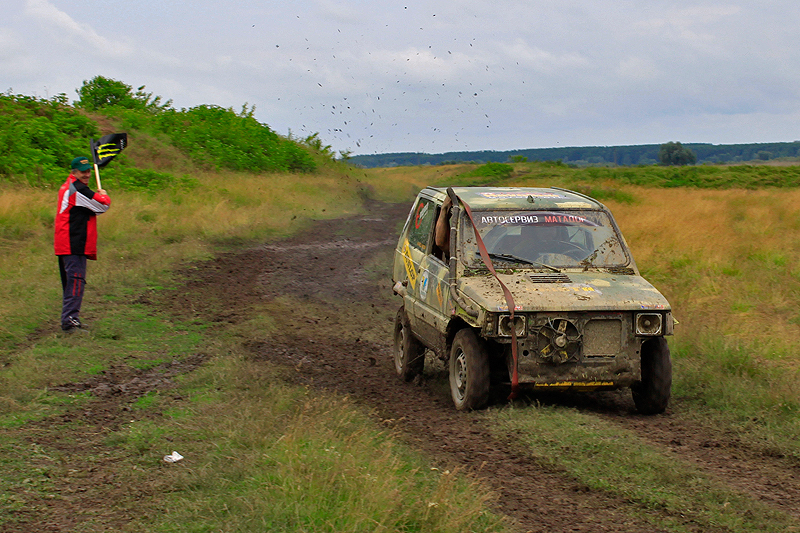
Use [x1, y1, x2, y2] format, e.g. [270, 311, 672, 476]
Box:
[0, 76, 318, 189]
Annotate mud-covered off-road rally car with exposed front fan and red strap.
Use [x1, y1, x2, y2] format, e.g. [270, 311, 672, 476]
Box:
[392, 187, 674, 414]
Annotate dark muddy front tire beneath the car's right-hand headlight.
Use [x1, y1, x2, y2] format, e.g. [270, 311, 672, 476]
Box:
[631, 337, 672, 415]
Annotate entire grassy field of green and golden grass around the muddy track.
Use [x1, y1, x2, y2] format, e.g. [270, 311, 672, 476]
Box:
[0, 163, 800, 532]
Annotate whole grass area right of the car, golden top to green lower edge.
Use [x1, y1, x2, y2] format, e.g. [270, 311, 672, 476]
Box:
[600, 188, 800, 460]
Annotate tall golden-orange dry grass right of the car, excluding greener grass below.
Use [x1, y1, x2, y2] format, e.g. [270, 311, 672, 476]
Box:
[609, 188, 800, 356]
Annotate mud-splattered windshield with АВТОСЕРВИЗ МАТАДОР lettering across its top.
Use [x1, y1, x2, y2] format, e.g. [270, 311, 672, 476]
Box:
[459, 210, 629, 268]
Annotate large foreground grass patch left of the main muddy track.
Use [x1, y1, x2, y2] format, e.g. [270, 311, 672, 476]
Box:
[128, 358, 499, 532]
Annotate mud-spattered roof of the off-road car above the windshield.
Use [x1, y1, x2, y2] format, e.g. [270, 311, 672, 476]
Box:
[423, 187, 605, 211]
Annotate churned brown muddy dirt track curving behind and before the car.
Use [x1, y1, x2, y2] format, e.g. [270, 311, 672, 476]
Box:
[7, 204, 800, 532]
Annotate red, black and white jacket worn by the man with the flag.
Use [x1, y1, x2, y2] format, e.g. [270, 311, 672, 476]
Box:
[55, 174, 111, 259]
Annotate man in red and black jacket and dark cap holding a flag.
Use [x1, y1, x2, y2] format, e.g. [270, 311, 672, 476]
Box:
[55, 157, 111, 333]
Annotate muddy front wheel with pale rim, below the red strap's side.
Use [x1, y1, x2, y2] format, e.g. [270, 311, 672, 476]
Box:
[449, 328, 490, 411]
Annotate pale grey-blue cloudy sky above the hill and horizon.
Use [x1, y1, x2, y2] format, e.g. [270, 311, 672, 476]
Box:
[0, 0, 800, 154]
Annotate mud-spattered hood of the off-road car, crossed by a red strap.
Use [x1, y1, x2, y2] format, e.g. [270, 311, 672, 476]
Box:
[458, 270, 670, 311]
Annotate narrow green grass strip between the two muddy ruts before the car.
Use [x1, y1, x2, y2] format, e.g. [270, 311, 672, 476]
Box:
[493, 405, 797, 532]
